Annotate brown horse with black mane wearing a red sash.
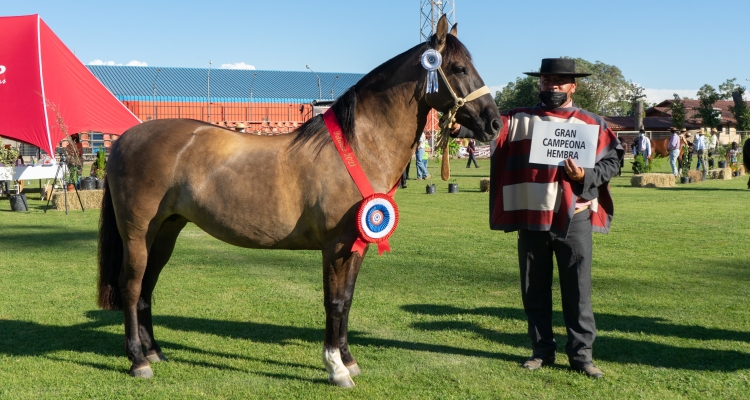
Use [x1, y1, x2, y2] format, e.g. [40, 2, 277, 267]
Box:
[98, 17, 502, 387]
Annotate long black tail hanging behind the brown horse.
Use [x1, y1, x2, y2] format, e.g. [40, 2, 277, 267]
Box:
[99, 178, 123, 310]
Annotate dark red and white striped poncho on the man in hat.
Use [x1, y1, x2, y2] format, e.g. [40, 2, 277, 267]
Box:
[490, 105, 623, 237]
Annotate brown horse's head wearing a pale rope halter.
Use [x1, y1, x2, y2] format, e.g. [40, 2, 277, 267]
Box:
[425, 16, 502, 142]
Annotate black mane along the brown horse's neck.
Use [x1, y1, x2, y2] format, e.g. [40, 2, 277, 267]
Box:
[289, 35, 471, 153]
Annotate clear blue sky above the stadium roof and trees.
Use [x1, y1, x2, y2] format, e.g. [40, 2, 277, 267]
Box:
[5, 0, 750, 101]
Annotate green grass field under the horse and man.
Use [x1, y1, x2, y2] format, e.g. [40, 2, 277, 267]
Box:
[0, 160, 750, 399]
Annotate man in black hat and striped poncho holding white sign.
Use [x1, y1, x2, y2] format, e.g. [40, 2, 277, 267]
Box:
[464, 58, 624, 378]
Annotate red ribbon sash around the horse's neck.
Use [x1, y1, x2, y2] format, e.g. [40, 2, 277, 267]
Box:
[323, 108, 400, 256]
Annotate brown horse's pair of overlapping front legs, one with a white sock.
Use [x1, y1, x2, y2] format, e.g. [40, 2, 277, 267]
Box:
[323, 244, 367, 387]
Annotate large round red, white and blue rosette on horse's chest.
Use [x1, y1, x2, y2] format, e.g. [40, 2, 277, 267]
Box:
[352, 193, 398, 255]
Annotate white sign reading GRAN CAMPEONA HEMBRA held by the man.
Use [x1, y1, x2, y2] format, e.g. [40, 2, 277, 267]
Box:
[529, 121, 599, 168]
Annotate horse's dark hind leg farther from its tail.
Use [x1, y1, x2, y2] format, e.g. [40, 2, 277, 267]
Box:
[138, 215, 187, 363]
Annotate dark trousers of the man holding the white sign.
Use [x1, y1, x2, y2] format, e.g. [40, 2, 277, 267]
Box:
[518, 211, 596, 367]
